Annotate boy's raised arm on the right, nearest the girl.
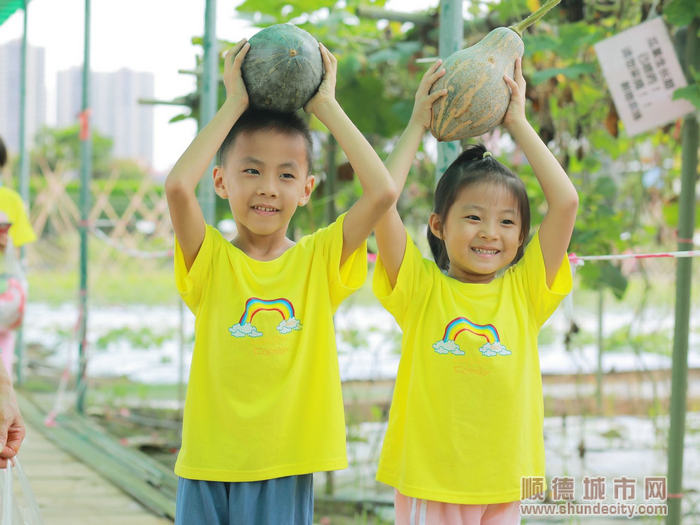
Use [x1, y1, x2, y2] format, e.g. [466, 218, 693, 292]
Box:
[305, 44, 396, 265]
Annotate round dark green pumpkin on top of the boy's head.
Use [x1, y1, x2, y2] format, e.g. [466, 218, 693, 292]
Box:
[241, 24, 323, 112]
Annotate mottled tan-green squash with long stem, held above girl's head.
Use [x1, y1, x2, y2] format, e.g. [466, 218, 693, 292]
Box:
[430, 0, 559, 141]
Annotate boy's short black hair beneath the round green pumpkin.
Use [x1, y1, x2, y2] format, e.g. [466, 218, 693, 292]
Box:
[217, 108, 313, 174]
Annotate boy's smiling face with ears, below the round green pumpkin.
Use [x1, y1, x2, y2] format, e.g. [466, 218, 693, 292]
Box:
[214, 129, 315, 242]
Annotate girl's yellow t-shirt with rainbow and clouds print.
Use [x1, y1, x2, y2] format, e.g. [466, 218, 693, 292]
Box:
[373, 230, 571, 504]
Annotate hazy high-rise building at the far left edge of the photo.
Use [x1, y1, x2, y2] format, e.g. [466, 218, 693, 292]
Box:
[0, 40, 46, 152]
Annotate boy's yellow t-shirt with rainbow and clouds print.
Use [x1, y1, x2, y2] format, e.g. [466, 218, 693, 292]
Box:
[175, 215, 367, 481]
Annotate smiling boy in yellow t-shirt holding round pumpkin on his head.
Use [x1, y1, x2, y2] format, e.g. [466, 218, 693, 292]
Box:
[165, 40, 396, 525]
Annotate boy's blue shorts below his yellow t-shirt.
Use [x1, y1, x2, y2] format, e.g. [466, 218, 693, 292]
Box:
[175, 474, 314, 525]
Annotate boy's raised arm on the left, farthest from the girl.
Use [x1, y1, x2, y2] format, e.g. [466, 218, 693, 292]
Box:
[165, 40, 250, 269]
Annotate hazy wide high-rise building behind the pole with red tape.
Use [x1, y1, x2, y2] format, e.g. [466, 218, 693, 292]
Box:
[56, 67, 154, 165]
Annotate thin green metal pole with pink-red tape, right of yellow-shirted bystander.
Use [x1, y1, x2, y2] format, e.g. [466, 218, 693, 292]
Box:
[76, 0, 92, 414]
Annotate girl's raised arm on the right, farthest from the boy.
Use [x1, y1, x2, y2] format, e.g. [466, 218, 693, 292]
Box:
[503, 59, 578, 286]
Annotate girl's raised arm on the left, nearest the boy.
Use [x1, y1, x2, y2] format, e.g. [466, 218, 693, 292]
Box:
[374, 60, 447, 287]
